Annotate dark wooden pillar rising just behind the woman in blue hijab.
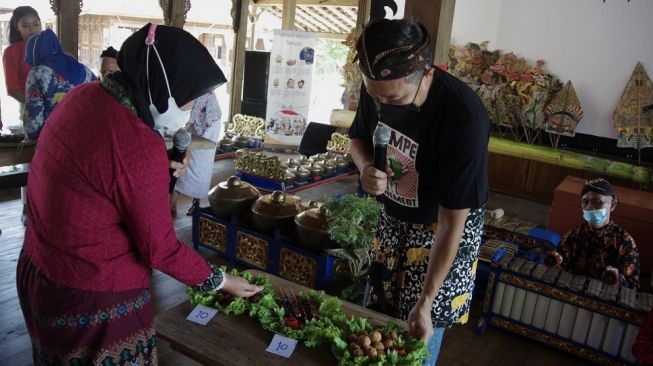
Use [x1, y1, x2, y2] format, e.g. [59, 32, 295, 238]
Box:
[50, 0, 82, 58]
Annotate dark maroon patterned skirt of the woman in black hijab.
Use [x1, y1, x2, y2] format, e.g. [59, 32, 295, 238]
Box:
[16, 252, 157, 366]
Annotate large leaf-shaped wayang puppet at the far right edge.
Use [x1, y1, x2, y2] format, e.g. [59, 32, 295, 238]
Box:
[612, 62, 653, 151]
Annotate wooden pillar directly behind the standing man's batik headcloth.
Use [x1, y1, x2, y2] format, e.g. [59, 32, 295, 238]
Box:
[404, 0, 456, 65]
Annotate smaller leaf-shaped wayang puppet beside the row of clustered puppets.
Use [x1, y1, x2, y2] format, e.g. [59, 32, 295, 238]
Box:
[545, 80, 583, 147]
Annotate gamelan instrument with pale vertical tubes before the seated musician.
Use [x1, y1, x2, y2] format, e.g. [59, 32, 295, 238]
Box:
[478, 255, 653, 365]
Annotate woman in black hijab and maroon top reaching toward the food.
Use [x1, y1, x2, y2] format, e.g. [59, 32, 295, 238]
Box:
[16, 24, 260, 365]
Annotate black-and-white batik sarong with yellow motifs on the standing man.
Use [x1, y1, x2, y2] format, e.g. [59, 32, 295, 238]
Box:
[369, 207, 485, 328]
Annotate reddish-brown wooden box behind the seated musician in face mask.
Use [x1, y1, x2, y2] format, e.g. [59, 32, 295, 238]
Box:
[547, 176, 653, 274]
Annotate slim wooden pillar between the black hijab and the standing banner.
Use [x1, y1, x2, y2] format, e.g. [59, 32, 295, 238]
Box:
[229, 0, 249, 121]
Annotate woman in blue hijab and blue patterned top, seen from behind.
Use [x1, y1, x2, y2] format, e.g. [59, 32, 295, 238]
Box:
[23, 29, 97, 140]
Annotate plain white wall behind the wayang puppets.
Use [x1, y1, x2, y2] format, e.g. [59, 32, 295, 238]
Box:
[452, 0, 653, 138]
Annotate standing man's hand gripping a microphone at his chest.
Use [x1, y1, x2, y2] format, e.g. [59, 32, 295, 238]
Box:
[361, 124, 392, 196]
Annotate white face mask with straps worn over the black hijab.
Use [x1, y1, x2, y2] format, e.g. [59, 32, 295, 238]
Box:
[145, 39, 191, 135]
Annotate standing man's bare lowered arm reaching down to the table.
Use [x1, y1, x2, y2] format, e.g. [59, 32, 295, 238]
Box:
[408, 206, 469, 341]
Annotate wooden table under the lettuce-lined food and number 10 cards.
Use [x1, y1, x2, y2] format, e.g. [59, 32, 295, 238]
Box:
[156, 270, 407, 366]
